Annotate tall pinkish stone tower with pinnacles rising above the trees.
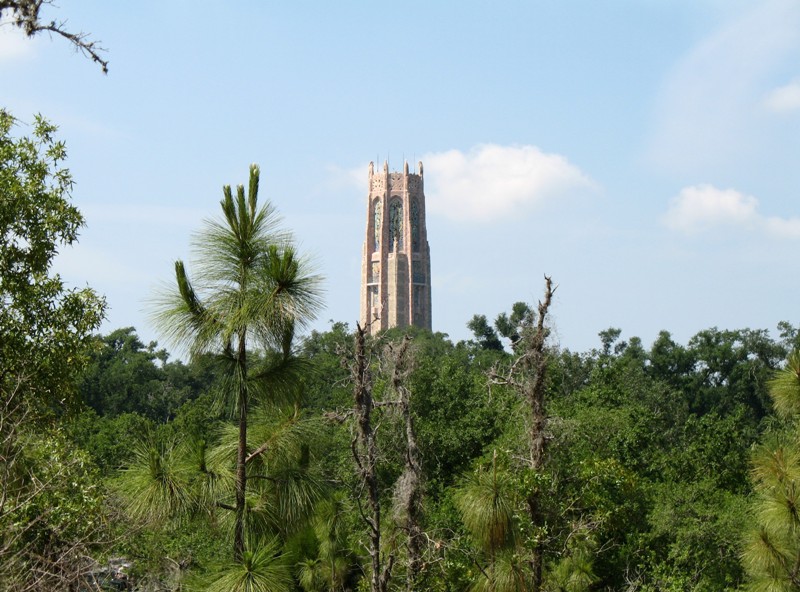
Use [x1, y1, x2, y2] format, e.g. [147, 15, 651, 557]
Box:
[361, 162, 431, 334]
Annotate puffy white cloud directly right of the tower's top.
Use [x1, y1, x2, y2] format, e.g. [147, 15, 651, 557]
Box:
[422, 144, 593, 221]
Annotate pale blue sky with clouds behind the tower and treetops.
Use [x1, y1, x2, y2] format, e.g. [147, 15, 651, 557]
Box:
[0, 0, 800, 351]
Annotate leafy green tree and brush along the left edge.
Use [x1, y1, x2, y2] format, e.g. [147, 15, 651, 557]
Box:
[0, 110, 105, 590]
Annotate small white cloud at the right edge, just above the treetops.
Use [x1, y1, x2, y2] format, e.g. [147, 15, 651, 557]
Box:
[663, 185, 800, 239]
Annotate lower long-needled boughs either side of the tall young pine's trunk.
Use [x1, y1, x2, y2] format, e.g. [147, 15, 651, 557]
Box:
[114, 402, 328, 585]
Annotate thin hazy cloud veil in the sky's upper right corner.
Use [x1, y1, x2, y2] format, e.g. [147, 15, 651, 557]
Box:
[649, 0, 800, 171]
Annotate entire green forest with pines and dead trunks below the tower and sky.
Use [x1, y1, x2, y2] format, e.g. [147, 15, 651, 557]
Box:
[0, 112, 800, 592]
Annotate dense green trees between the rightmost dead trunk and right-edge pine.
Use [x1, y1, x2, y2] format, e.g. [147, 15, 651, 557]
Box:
[540, 330, 777, 590]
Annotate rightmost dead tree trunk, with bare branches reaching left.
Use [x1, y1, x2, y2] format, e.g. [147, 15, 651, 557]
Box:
[491, 276, 556, 592]
